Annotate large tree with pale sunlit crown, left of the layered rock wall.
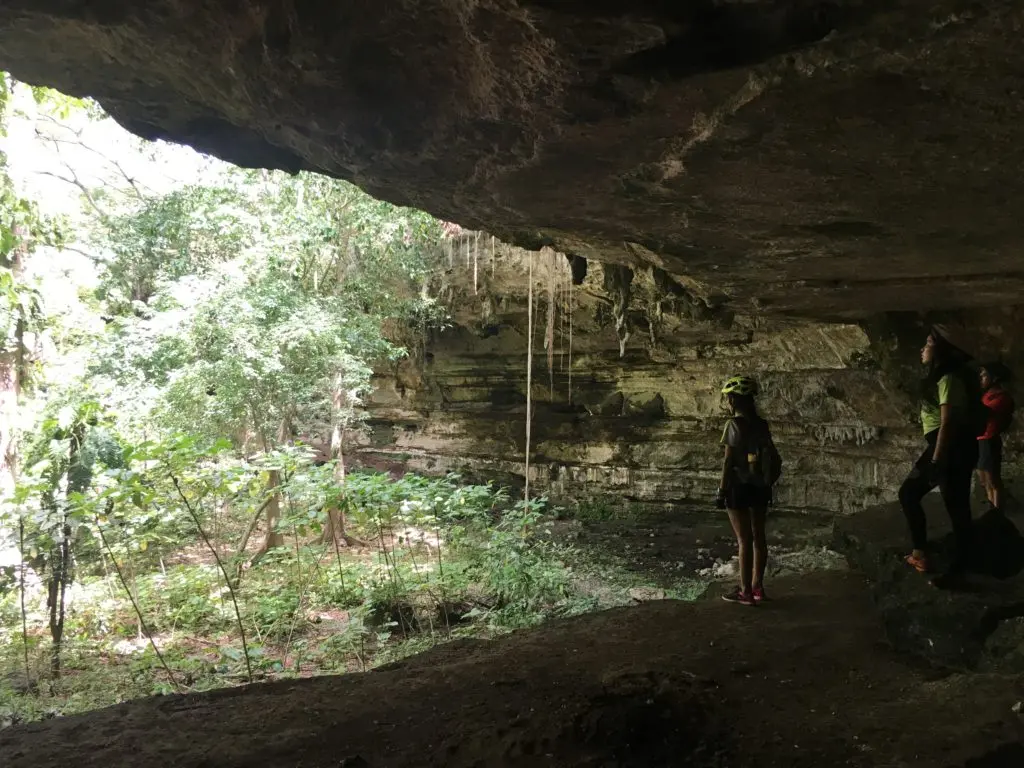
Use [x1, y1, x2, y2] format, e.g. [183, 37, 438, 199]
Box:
[66, 171, 441, 561]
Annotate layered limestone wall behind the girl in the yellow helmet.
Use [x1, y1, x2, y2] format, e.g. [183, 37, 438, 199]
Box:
[357, 242, 999, 513]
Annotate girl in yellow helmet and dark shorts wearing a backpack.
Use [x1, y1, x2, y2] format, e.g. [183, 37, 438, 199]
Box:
[719, 376, 777, 605]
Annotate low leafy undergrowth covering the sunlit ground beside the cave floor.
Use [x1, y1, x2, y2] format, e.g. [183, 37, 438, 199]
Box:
[0, 474, 614, 725]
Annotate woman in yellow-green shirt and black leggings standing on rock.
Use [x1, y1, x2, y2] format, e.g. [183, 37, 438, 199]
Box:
[899, 326, 980, 586]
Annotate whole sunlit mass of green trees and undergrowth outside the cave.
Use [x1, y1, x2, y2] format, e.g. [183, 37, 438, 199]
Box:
[0, 79, 618, 723]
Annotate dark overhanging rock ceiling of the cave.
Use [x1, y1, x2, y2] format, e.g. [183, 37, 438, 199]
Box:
[0, 0, 1024, 318]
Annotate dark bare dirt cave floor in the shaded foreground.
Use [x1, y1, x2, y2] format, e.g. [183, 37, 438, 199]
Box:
[0, 570, 1024, 768]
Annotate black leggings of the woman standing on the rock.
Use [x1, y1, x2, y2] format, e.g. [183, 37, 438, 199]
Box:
[899, 430, 978, 570]
